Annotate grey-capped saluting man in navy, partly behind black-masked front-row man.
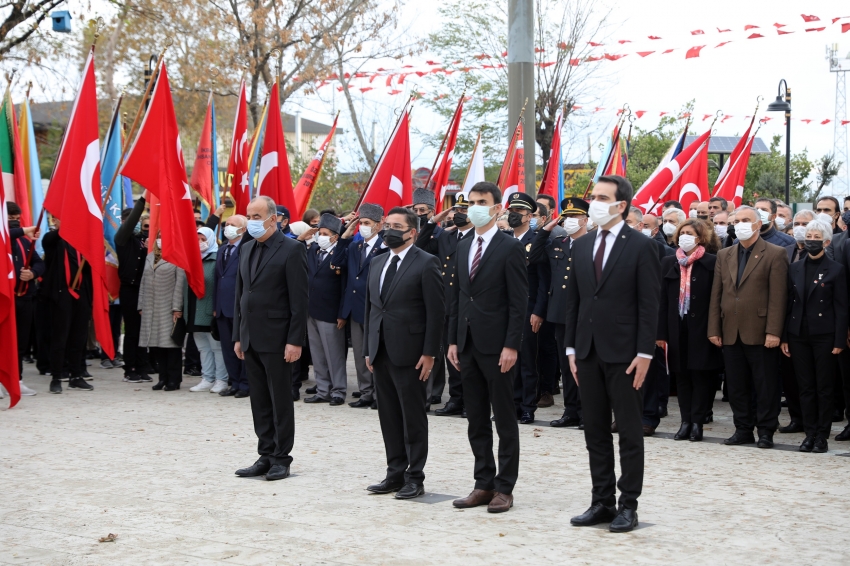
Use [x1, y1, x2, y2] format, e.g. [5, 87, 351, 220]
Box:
[334, 202, 389, 409]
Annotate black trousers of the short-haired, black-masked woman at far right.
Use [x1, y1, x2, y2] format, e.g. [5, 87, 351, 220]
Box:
[788, 334, 835, 439]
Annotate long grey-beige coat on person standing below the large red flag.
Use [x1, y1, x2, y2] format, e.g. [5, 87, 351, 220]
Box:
[139, 253, 186, 348]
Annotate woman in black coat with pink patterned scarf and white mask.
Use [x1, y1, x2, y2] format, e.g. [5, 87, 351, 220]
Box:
[658, 218, 723, 442]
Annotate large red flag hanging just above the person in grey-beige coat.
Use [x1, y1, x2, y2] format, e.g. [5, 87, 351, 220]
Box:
[121, 62, 204, 298]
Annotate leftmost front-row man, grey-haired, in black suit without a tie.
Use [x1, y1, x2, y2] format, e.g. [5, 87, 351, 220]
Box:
[233, 196, 307, 480]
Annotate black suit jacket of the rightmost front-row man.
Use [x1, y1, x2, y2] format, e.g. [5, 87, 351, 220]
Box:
[564, 224, 661, 363]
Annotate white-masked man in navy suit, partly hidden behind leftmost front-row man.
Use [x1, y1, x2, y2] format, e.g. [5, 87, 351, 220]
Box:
[213, 214, 248, 399]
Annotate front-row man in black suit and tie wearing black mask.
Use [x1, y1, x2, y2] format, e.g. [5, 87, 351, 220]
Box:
[363, 207, 446, 499]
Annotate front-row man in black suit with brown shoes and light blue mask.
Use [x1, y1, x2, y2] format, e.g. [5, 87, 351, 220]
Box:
[448, 182, 528, 513]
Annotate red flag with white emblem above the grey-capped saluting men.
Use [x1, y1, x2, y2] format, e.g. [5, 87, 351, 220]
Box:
[360, 112, 413, 213]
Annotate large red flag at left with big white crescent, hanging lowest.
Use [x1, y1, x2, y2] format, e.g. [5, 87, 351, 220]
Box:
[44, 50, 115, 359]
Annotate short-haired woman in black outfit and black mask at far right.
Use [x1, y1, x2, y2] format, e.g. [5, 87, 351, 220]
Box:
[781, 220, 848, 453]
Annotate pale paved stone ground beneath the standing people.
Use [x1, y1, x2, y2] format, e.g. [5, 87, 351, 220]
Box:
[0, 362, 850, 566]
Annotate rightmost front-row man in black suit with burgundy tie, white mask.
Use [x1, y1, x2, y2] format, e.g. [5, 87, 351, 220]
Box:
[564, 175, 661, 532]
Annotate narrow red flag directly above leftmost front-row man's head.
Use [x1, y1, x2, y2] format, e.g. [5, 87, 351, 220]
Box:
[257, 82, 301, 218]
